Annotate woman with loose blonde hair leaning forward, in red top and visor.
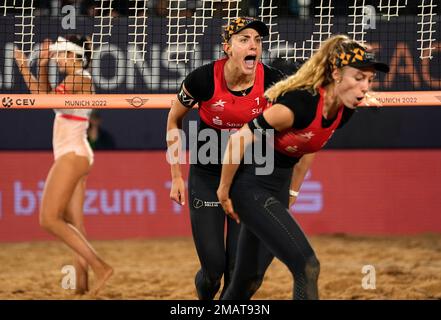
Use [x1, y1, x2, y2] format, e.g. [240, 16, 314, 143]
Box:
[217, 35, 389, 299]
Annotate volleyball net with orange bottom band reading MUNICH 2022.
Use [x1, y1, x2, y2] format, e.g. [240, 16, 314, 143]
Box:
[0, 0, 441, 109]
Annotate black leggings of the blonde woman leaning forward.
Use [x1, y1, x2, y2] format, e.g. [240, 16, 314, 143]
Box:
[223, 165, 320, 300]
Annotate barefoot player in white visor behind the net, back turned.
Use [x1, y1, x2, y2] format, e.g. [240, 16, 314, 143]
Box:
[14, 35, 113, 294]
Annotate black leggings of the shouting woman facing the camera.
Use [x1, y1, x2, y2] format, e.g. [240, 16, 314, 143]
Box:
[189, 165, 273, 300]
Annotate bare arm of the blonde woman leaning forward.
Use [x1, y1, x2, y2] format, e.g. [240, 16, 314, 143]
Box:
[217, 104, 294, 223]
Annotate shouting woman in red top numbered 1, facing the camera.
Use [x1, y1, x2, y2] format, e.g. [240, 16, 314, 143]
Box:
[167, 18, 300, 299]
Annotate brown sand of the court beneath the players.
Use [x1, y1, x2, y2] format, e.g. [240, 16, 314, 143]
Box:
[0, 235, 441, 300]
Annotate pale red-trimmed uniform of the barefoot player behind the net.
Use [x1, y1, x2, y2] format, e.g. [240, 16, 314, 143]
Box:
[52, 70, 93, 164]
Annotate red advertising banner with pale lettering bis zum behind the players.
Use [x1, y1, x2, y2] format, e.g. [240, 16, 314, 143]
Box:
[0, 150, 441, 241]
